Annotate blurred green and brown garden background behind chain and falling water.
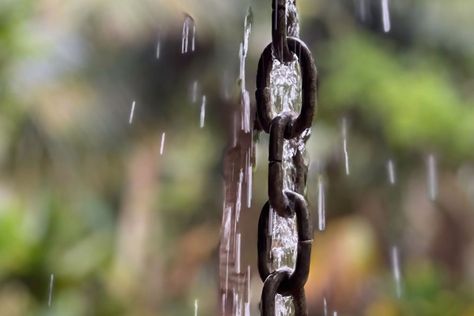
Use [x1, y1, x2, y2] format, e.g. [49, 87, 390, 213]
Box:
[0, 0, 474, 316]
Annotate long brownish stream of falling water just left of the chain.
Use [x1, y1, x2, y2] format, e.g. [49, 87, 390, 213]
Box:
[219, 8, 254, 316]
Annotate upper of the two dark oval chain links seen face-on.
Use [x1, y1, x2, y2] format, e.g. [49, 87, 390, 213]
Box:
[255, 37, 317, 139]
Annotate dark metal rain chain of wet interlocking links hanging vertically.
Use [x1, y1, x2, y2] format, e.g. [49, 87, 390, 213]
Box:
[255, 0, 317, 316]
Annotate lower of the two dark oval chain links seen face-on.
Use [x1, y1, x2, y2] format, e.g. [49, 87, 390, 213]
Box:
[257, 190, 313, 295]
